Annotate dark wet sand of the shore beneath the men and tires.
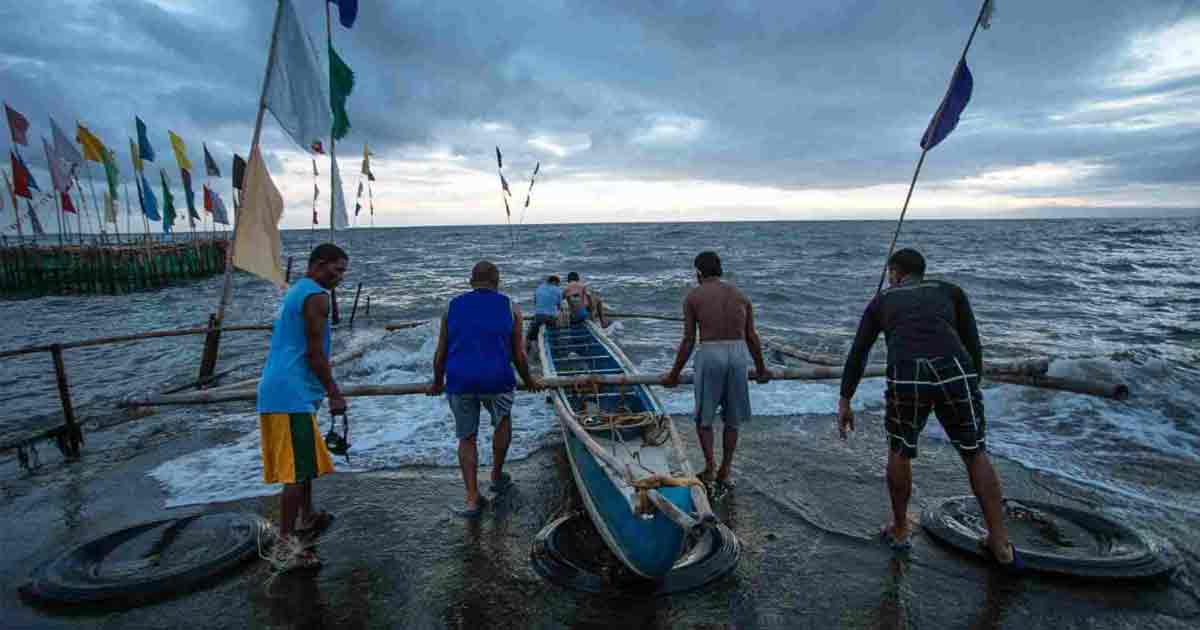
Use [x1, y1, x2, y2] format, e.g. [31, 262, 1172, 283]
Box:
[0, 415, 1200, 630]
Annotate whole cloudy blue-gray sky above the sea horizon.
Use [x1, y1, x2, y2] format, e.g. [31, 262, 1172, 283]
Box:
[0, 0, 1200, 227]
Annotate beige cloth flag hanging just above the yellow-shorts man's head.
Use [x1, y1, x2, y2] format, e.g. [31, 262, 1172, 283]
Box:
[236, 146, 288, 288]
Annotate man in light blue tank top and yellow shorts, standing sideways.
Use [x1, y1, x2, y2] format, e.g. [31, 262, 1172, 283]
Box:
[258, 242, 349, 570]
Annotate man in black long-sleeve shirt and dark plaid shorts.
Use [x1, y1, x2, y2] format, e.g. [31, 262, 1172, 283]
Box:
[838, 250, 1015, 565]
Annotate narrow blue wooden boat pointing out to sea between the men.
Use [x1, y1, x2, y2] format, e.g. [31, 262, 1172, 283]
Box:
[539, 322, 732, 580]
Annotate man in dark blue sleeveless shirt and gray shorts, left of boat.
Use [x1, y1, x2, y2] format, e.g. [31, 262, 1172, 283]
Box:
[430, 260, 541, 518]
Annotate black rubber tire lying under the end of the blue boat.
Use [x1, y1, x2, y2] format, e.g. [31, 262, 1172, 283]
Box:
[529, 515, 742, 596]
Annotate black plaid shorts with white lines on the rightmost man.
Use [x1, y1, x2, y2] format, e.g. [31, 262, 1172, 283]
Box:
[884, 356, 988, 458]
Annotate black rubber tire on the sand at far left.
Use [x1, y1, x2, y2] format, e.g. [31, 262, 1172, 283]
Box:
[18, 512, 264, 607]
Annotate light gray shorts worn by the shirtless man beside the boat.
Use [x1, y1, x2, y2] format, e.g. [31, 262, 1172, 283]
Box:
[694, 340, 750, 430]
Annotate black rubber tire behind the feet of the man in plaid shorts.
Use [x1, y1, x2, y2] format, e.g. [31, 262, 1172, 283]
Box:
[920, 496, 1177, 578]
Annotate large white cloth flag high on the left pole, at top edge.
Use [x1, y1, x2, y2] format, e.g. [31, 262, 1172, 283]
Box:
[265, 0, 334, 151]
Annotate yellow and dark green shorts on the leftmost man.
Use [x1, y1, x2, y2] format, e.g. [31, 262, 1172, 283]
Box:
[258, 413, 334, 484]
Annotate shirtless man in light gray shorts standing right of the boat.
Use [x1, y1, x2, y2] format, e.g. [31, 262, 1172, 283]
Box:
[662, 252, 770, 493]
